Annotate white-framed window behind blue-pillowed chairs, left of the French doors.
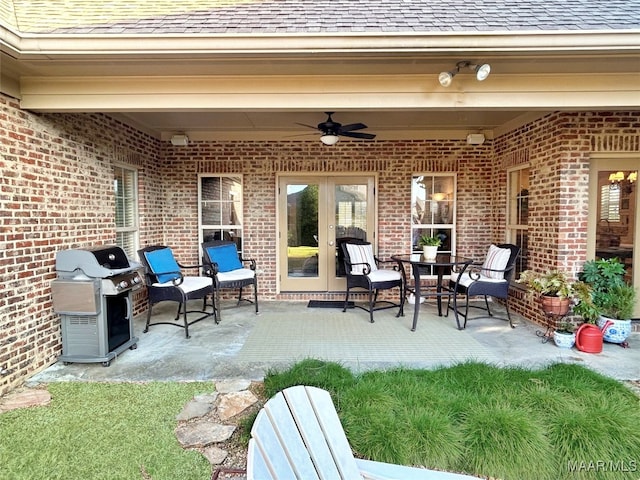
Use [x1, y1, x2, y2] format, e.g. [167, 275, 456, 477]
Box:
[198, 175, 242, 251]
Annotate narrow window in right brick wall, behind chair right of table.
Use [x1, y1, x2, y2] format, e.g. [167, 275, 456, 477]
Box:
[507, 166, 529, 278]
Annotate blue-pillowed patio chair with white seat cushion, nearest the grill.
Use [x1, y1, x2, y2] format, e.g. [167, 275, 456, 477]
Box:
[138, 245, 219, 338]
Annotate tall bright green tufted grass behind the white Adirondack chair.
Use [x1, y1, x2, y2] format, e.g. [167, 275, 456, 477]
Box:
[265, 360, 640, 480]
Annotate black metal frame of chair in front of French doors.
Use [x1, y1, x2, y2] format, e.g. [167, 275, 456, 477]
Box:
[341, 239, 406, 323]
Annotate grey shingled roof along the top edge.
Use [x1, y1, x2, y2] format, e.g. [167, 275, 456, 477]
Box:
[0, 0, 640, 35]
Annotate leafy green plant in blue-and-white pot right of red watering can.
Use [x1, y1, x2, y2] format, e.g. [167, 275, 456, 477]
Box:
[580, 258, 636, 345]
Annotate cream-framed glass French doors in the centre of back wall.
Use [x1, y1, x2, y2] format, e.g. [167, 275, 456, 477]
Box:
[278, 176, 375, 292]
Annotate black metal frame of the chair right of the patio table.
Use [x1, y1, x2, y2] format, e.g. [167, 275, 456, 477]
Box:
[447, 243, 520, 330]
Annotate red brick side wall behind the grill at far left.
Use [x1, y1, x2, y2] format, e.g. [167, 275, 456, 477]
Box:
[0, 96, 162, 395]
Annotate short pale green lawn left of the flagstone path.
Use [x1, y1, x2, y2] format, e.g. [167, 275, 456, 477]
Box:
[0, 382, 214, 480]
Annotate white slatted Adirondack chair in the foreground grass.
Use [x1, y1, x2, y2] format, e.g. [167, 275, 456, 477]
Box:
[247, 385, 478, 480]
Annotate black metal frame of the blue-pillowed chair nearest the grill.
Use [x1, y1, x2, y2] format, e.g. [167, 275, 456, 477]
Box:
[138, 245, 220, 338]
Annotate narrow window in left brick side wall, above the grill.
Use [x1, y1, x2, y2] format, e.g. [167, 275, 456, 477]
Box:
[113, 165, 138, 258]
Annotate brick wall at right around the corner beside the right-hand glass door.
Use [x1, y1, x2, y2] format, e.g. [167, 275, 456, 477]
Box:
[494, 112, 640, 323]
